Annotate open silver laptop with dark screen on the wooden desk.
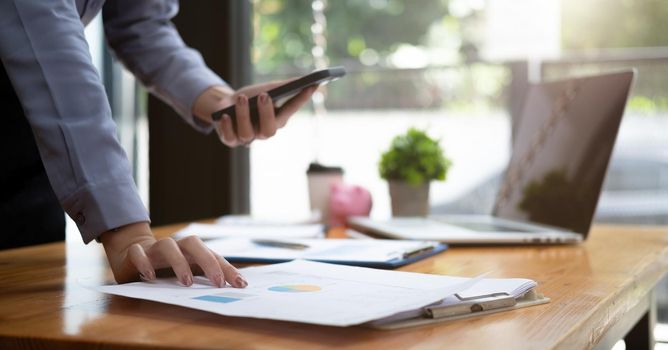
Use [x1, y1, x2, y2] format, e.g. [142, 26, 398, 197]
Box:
[348, 70, 635, 244]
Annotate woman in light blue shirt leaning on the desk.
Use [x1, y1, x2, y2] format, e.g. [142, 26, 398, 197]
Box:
[0, 0, 314, 287]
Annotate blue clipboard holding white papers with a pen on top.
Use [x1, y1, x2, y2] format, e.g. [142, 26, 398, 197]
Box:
[206, 238, 448, 269]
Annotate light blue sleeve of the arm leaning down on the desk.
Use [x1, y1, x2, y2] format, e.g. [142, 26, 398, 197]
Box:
[0, 0, 149, 243]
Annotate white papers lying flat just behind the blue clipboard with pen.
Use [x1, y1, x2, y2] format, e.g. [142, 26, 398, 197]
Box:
[174, 223, 325, 239]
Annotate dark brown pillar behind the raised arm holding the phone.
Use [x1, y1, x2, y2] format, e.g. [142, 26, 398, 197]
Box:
[148, 0, 251, 225]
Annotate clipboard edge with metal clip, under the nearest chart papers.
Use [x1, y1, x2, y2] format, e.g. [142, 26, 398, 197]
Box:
[366, 289, 550, 330]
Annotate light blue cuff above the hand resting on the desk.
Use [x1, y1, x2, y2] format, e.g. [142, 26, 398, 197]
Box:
[63, 181, 150, 244]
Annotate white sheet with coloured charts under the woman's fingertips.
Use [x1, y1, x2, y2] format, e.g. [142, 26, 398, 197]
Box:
[95, 260, 480, 326]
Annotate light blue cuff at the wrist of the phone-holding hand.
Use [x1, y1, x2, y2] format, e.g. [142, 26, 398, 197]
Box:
[162, 67, 228, 134]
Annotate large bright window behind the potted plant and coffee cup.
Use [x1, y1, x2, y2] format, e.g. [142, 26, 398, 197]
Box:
[251, 0, 510, 217]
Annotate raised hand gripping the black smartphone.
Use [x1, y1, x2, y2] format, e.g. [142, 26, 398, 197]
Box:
[193, 81, 317, 147]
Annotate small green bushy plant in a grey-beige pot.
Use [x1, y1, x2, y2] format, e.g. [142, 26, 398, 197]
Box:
[378, 128, 452, 216]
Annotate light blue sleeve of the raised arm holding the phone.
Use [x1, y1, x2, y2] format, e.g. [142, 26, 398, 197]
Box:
[102, 0, 226, 132]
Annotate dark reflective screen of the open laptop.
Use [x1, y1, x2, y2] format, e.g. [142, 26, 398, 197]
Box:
[493, 71, 634, 236]
